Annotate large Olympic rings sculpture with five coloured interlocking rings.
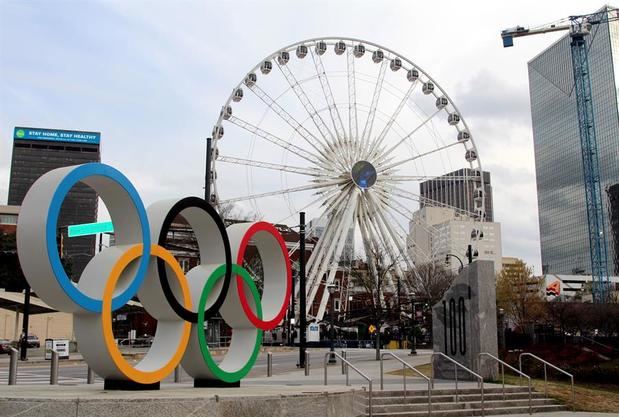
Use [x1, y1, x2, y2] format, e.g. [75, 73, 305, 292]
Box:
[17, 163, 291, 384]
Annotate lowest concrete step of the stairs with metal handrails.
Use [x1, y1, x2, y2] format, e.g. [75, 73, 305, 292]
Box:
[366, 398, 556, 414]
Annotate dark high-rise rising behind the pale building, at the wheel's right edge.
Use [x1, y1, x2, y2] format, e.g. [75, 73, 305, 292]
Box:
[419, 168, 494, 222]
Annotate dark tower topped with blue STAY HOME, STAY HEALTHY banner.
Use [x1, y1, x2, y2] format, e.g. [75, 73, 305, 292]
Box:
[8, 127, 101, 279]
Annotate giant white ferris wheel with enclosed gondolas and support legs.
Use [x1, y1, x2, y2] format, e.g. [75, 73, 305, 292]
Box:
[210, 37, 485, 320]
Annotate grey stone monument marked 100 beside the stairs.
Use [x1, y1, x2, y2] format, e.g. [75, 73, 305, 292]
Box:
[432, 261, 498, 379]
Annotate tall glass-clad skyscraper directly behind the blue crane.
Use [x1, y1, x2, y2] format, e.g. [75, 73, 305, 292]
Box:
[528, 7, 619, 274]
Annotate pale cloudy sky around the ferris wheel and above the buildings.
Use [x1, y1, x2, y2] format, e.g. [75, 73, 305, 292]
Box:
[0, 0, 602, 273]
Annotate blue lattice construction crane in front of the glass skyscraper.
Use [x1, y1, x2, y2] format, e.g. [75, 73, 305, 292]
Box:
[501, 7, 619, 303]
